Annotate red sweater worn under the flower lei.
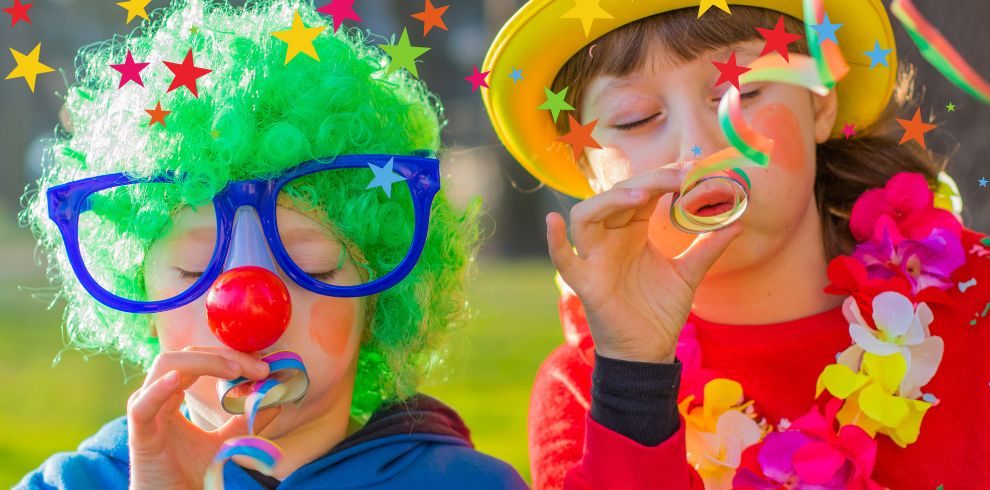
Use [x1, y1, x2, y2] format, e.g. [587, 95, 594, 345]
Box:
[529, 230, 990, 490]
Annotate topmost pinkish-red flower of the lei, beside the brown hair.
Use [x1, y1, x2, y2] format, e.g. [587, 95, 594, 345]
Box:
[849, 172, 962, 244]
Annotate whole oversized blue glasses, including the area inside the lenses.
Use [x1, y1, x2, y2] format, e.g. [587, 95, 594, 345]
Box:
[47, 152, 440, 313]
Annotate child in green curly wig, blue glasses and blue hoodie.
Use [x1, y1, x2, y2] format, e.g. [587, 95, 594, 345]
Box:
[17, 0, 525, 489]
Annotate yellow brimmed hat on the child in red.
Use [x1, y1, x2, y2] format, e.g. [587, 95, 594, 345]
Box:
[482, 0, 897, 198]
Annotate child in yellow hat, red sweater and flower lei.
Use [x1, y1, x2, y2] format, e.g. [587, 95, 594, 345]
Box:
[483, 0, 990, 489]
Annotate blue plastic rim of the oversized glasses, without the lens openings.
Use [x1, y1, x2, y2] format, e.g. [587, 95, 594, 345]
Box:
[47, 151, 440, 313]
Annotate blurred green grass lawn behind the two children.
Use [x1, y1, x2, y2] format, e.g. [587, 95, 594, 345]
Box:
[0, 221, 562, 488]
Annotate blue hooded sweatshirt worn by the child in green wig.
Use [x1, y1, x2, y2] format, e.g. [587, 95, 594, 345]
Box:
[14, 395, 527, 490]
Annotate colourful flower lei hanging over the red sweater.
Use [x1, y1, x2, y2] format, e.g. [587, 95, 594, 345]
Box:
[677, 173, 975, 489]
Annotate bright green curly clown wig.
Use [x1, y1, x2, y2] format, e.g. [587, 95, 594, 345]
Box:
[21, 0, 479, 418]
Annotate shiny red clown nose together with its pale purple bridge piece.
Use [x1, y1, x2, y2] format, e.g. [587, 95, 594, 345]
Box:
[206, 207, 292, 352]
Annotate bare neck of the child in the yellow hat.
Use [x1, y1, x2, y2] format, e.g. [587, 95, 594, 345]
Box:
[692, 197, 843, 325]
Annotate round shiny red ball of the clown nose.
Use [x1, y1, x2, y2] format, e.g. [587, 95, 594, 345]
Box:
[206, 265, 292, 352]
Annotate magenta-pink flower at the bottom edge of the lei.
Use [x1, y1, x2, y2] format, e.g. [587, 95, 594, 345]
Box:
[732, 400, 882, 490]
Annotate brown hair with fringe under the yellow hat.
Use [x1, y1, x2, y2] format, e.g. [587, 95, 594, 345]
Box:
[553, 6, 944, 259]
